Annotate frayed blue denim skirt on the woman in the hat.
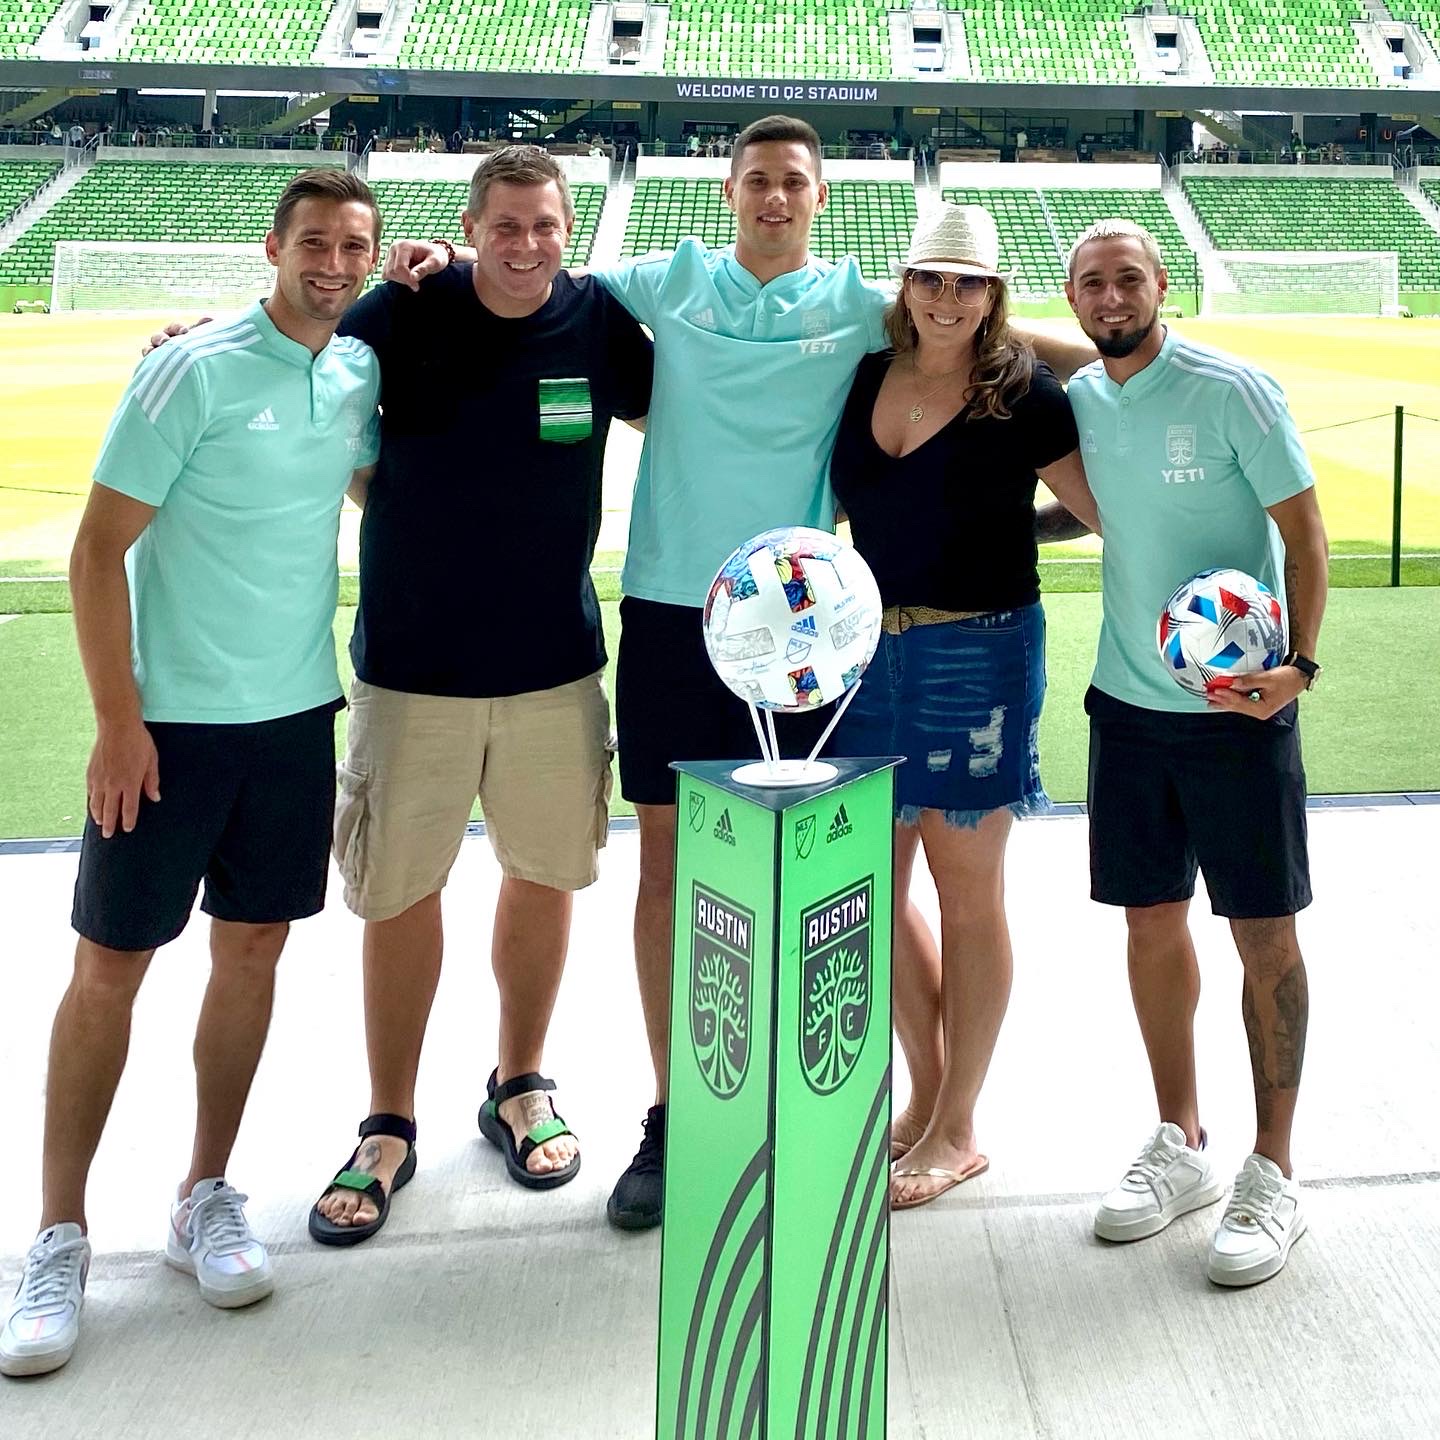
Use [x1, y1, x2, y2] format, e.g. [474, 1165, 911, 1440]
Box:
[827, 605, 1051, 829]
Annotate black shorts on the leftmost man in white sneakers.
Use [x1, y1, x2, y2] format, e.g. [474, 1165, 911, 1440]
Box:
[71, 700, 341, 950]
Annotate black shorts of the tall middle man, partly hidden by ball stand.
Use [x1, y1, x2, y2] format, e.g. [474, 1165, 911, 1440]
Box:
[615, 596, 834, 805]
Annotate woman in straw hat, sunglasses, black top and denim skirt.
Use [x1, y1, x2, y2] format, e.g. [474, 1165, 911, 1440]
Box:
[831, 204, 1099, 1208]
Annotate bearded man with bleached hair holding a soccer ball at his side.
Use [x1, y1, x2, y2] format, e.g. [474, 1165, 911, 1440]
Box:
[1066, 220, 1326, 1286]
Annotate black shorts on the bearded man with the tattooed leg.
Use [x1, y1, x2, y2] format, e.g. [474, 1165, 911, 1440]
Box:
[1084, 685, 1310, 920]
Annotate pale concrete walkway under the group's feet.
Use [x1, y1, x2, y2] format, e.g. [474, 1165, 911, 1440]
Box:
[0, 805, 1440, 1440]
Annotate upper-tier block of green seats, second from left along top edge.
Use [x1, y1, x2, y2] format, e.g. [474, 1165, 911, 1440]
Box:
[117, 0, 330, 65]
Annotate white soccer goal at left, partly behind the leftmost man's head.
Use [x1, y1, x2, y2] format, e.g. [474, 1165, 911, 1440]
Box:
[50, 240, 275, 311]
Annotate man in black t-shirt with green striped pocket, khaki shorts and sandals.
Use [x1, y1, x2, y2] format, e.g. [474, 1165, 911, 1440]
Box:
[310, 145, 652, 1244]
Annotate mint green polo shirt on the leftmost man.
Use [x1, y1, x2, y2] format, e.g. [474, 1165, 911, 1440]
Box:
[95, 304, 380, 724]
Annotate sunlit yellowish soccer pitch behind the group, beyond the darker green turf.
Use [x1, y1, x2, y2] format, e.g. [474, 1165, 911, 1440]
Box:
[0, 314, 1440, 573]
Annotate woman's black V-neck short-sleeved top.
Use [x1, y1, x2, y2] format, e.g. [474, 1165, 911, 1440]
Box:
[829, 351, 1079, 611]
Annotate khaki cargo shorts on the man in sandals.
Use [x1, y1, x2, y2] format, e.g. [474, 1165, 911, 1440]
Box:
[334, 671, 613, 920]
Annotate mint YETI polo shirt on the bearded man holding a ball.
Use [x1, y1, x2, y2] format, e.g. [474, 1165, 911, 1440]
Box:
[1070, 331, 1315, 711]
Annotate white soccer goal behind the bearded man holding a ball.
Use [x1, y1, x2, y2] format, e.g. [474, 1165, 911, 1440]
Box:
[1200, 251, 1400, 315]
